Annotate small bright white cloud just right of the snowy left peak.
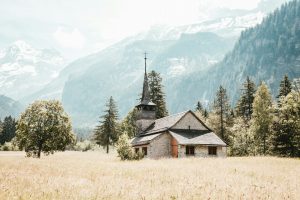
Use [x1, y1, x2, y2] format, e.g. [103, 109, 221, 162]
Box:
[53, 27, 85, 49]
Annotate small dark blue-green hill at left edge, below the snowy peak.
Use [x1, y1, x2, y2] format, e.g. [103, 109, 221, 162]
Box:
[0, 95, 23, 119]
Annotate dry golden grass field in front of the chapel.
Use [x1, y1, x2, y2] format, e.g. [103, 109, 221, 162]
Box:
[0, 152, 300, 200]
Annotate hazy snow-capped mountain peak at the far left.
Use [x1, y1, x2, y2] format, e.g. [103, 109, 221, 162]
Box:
[0, 40, 64, 99]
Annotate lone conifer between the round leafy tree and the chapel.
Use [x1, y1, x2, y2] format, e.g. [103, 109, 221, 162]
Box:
[94, 97, 119, 153]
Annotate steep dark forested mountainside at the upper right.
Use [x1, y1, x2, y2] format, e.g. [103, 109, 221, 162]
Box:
[172, 1, 300, 108]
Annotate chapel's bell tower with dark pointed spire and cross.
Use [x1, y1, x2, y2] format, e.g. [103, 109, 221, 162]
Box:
[136, 52, 156, 135]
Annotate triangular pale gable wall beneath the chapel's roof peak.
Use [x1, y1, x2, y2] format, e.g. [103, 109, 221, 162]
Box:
[173, 113, 207, 130]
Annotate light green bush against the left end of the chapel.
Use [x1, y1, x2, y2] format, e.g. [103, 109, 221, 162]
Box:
[117, 133, 144, 160]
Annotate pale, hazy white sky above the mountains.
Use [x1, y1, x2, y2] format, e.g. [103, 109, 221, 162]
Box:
[0, 0, 274, 60]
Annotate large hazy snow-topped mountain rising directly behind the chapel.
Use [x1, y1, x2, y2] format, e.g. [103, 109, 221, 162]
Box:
[25, 0, 292, 127]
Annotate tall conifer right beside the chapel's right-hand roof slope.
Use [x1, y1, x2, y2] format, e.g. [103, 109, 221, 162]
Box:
[209, 86, 231, 144]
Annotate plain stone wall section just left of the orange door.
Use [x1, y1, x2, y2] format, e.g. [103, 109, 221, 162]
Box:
[148, 133, 172, 159]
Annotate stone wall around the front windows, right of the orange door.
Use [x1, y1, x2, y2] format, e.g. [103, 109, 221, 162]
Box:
[178, 145, 226, 158]
